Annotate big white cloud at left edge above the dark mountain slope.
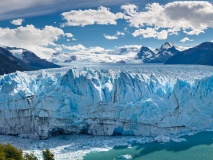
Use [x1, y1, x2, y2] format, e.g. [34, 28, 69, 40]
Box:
[0, 25, 64, 58]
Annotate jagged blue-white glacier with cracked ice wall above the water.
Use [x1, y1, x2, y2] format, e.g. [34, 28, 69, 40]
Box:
[0, 65, 213, 139]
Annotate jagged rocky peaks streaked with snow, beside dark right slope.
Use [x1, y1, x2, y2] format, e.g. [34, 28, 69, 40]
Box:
[136, 42, 180, 63]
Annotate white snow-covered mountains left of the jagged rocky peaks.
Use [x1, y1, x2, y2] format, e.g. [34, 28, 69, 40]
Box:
[48, 45, 142, 64]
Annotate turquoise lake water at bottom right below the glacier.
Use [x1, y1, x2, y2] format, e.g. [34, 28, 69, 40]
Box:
[84, 132, 213, 160]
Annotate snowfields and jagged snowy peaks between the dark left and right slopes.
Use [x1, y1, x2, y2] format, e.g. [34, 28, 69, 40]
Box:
[48, 42, 185, 63]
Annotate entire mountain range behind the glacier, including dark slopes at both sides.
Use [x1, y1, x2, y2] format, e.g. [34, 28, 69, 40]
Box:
[0, 42, 213, 75]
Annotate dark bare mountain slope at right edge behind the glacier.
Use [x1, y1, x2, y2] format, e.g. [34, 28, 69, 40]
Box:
[165, 42, 213, 65]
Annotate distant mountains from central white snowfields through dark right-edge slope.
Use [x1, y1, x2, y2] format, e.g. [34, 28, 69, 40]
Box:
[50, 42, 213, 65]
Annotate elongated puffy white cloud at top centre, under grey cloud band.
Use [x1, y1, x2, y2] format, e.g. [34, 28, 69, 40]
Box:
[61, 6, 123, 27]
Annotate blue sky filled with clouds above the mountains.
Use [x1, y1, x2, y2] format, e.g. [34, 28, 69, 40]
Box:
[0, 0, 213, 57]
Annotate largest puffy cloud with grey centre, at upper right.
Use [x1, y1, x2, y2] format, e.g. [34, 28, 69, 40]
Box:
[123, 1, 213, 35]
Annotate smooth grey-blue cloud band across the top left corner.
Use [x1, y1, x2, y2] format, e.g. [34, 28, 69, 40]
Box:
[0, 0, 133, 20]
